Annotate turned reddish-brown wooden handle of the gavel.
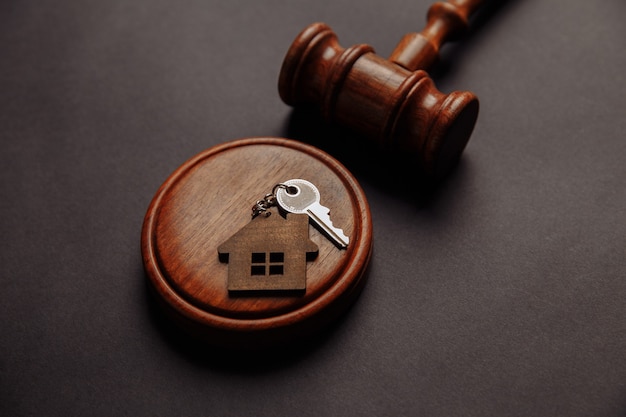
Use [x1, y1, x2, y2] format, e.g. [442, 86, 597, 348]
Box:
[389, 0, 483, 71]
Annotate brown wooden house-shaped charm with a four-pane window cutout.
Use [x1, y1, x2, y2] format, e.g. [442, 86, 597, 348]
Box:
[217, 213, 318, 292]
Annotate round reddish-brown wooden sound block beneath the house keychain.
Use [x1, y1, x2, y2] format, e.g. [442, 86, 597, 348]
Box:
[141, 138, 372, 348]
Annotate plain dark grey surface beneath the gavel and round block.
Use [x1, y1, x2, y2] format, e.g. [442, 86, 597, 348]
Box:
[0, 0, 626, 417]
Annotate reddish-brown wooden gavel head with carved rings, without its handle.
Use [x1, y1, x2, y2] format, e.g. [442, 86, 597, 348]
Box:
[278, 23, 478, 178]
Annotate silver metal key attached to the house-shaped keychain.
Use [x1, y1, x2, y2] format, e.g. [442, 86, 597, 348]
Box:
[276, 179, 350, 249]
